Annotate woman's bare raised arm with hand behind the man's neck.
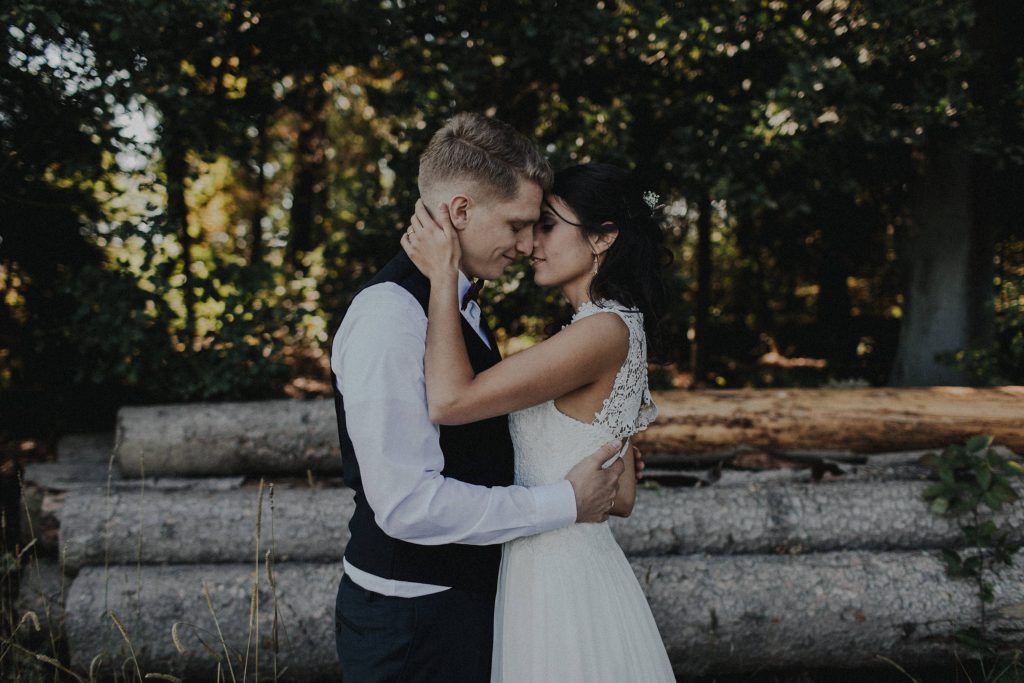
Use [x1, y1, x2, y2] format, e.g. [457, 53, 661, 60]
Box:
[402, 197, 629, 424]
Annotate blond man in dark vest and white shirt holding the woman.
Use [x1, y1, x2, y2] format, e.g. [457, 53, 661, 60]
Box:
[331, 114, 623, 683]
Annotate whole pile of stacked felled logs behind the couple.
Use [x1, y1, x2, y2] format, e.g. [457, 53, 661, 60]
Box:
[18, 388, 1024, 681]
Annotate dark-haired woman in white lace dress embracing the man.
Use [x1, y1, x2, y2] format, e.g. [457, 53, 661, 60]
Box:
[402, 164, 675, 683]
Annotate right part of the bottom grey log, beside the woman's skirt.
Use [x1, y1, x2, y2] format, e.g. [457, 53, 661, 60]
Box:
[633, 551, 1024, 675]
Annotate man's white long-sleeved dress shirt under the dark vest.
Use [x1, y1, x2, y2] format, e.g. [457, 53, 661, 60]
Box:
[331, 272, 577, 597]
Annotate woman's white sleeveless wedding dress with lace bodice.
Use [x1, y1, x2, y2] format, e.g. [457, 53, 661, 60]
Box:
[490, 301, 676, 683]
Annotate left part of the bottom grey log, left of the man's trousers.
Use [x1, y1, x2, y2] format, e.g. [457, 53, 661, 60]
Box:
[65, 562, 341, 681]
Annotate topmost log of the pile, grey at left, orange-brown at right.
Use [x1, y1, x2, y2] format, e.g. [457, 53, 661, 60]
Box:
[116, 387, 1024, 476]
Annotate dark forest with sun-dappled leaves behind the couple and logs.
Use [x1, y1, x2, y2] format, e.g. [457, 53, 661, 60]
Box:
[0, 0, 1024, 437]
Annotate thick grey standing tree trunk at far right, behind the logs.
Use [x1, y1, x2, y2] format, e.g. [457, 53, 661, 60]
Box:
[890, 0, 1024, 386]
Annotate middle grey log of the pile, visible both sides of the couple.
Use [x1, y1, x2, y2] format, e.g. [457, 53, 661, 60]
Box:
[60, 481, 1024, 569]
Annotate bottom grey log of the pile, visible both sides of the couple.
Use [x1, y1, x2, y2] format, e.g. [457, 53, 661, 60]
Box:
[67, 551, 1024, 681]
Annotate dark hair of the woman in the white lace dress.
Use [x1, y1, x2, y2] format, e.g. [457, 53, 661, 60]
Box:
[549, 163, 673, 361]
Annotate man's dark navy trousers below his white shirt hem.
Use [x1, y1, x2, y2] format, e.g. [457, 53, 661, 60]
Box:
[335, 575, 495, 683]
